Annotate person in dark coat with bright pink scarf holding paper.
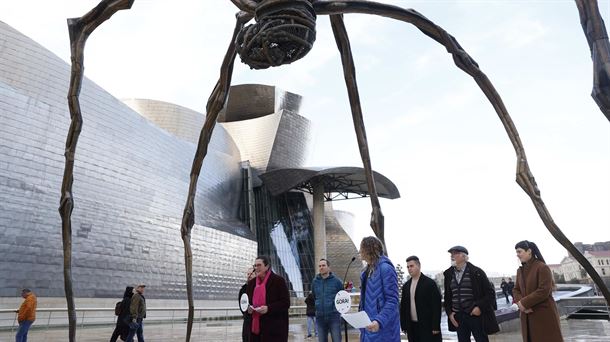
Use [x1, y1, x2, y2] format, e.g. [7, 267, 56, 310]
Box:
[246, 255, 290, 342]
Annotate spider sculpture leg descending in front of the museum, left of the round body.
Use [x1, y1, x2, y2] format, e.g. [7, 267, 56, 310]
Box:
[180, 12, 252, 342]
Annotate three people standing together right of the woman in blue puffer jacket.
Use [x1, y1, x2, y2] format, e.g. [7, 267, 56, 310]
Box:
[400, 240, 563, 342]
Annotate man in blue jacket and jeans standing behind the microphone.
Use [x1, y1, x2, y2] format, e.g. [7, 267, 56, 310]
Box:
[311, 259, 343, 342]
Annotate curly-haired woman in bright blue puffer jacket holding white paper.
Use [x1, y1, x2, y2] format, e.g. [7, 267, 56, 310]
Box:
[360, 236, 400, 342]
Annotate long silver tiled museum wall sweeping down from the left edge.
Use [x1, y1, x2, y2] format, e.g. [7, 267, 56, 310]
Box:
[0, 22, 257, 299]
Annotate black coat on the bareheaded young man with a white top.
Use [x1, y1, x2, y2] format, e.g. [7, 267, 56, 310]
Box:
[400, 274, 442, 342]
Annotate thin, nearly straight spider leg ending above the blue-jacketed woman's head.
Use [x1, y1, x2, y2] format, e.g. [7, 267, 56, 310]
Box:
[330, 14, 385, 245]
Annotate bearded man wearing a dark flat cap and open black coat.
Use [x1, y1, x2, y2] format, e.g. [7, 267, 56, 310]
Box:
[443, 246, 500, 342]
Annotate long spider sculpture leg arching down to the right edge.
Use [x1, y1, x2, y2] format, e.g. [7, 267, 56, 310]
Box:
[313, 0, 610, 303]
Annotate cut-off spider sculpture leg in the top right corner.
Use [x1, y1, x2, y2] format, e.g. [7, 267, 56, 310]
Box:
[576, 0, 610, 120]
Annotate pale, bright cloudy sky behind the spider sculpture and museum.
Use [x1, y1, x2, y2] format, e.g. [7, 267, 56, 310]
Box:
[0, 0, 610, 275]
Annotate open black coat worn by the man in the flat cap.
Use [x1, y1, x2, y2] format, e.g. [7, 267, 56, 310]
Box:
[443, 263, 500, 334]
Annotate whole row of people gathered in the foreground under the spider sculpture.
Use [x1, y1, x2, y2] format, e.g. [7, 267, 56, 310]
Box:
[234, 236, 563, 342]
